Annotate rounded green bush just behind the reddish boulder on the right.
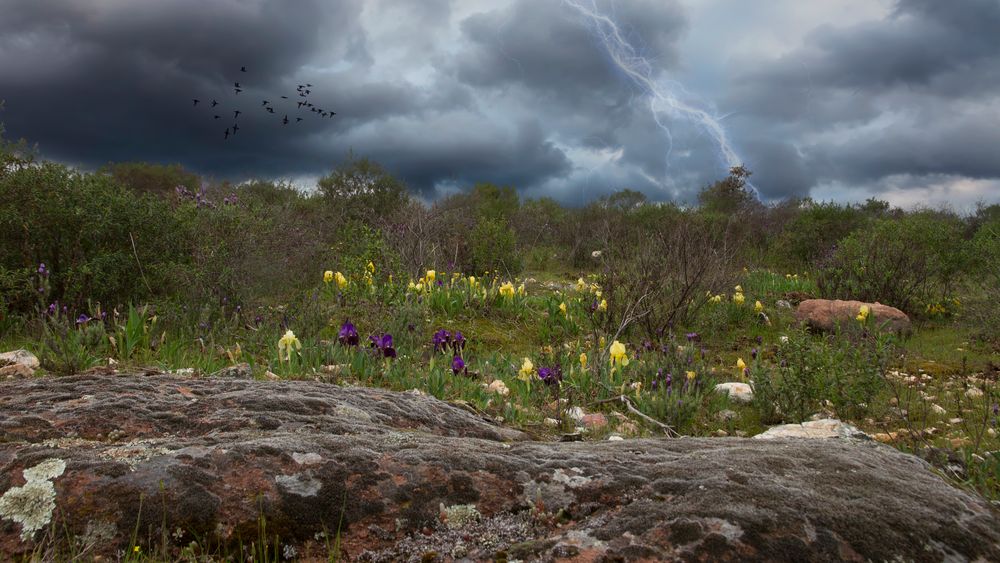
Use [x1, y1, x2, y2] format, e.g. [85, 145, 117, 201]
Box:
[816, 212, 967, 314]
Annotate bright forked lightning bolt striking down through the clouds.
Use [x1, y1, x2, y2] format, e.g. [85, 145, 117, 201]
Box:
[563, 0, 756, 192]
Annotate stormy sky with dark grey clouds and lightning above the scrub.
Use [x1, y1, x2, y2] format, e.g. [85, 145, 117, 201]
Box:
[0, 0, 1000, 210]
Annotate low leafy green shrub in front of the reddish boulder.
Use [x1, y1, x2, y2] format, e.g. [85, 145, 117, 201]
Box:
[749, 331, 891, 423]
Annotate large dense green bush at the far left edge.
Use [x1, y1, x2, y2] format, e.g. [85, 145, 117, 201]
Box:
[0, 162, 189, 312]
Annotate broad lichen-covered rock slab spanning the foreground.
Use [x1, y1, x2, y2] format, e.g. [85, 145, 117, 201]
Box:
[0, 375, 1000, 561]
